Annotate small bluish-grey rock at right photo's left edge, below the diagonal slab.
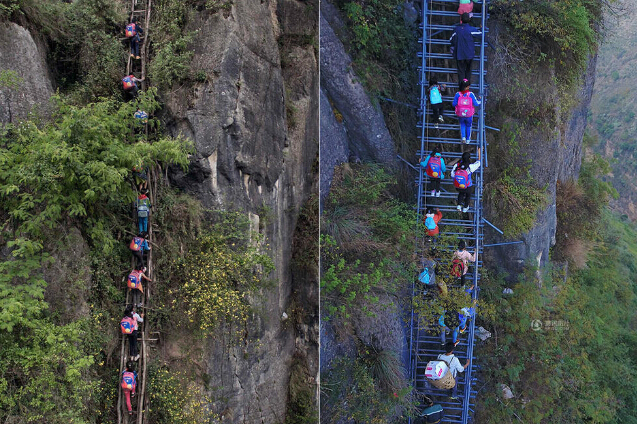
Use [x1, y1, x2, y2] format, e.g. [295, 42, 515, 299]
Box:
[320, 90, 349, 211]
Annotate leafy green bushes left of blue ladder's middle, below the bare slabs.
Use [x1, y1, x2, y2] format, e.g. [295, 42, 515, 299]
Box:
[321, 165, 422, 319]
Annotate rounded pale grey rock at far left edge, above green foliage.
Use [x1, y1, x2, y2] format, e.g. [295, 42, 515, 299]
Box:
[0, 22, 53, 123]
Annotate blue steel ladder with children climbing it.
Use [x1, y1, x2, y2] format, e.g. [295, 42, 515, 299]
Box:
[409, 0, 488, 424]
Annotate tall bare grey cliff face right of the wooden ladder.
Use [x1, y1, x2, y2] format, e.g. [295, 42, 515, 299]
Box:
[160, 0, 319, 423]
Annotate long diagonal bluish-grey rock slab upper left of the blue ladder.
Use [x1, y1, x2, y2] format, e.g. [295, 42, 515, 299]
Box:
[320, 2, 396, 166]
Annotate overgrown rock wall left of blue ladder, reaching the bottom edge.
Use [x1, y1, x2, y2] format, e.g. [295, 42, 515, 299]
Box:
[321, 164, 420, 423]
